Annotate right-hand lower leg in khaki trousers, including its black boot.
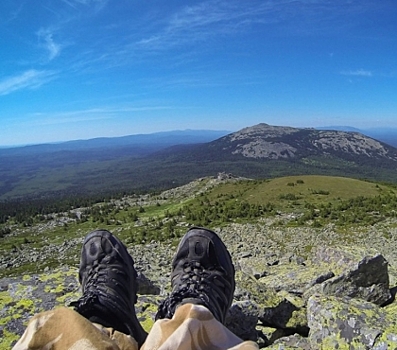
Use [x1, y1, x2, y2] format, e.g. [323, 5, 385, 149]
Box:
[148, 227, 258, 350]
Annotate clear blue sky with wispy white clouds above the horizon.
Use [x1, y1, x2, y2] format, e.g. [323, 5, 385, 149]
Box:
[0, 0, 397, 146]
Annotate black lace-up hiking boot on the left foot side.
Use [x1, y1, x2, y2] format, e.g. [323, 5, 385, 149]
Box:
[70, 230, 147, 346]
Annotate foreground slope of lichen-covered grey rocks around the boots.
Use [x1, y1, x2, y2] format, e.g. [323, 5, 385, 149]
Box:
[0, 215, 397, 349]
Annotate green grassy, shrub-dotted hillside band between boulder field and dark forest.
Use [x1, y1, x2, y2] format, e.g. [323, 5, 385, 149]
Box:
[0, 175, 397, 277]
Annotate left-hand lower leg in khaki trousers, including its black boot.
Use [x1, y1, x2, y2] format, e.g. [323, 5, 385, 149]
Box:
[14, 230, 147, 350]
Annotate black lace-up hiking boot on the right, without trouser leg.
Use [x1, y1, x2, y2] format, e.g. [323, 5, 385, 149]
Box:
[156, 227, 235, 323]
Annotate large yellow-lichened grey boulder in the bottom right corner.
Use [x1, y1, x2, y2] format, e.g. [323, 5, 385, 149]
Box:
[307, 294, 397, 349]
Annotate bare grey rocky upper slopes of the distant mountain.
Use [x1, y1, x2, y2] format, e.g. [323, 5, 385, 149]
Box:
[215, 124, 397, 161]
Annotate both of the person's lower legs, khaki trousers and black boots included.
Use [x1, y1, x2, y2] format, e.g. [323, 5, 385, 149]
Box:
[14, 228, 258, 350]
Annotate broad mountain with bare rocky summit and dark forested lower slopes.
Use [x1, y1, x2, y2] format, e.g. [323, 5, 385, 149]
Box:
[150, 124, 397, 183]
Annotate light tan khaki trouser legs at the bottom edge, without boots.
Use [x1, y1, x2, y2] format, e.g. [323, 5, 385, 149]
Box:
[13, 304, 259, 350]
